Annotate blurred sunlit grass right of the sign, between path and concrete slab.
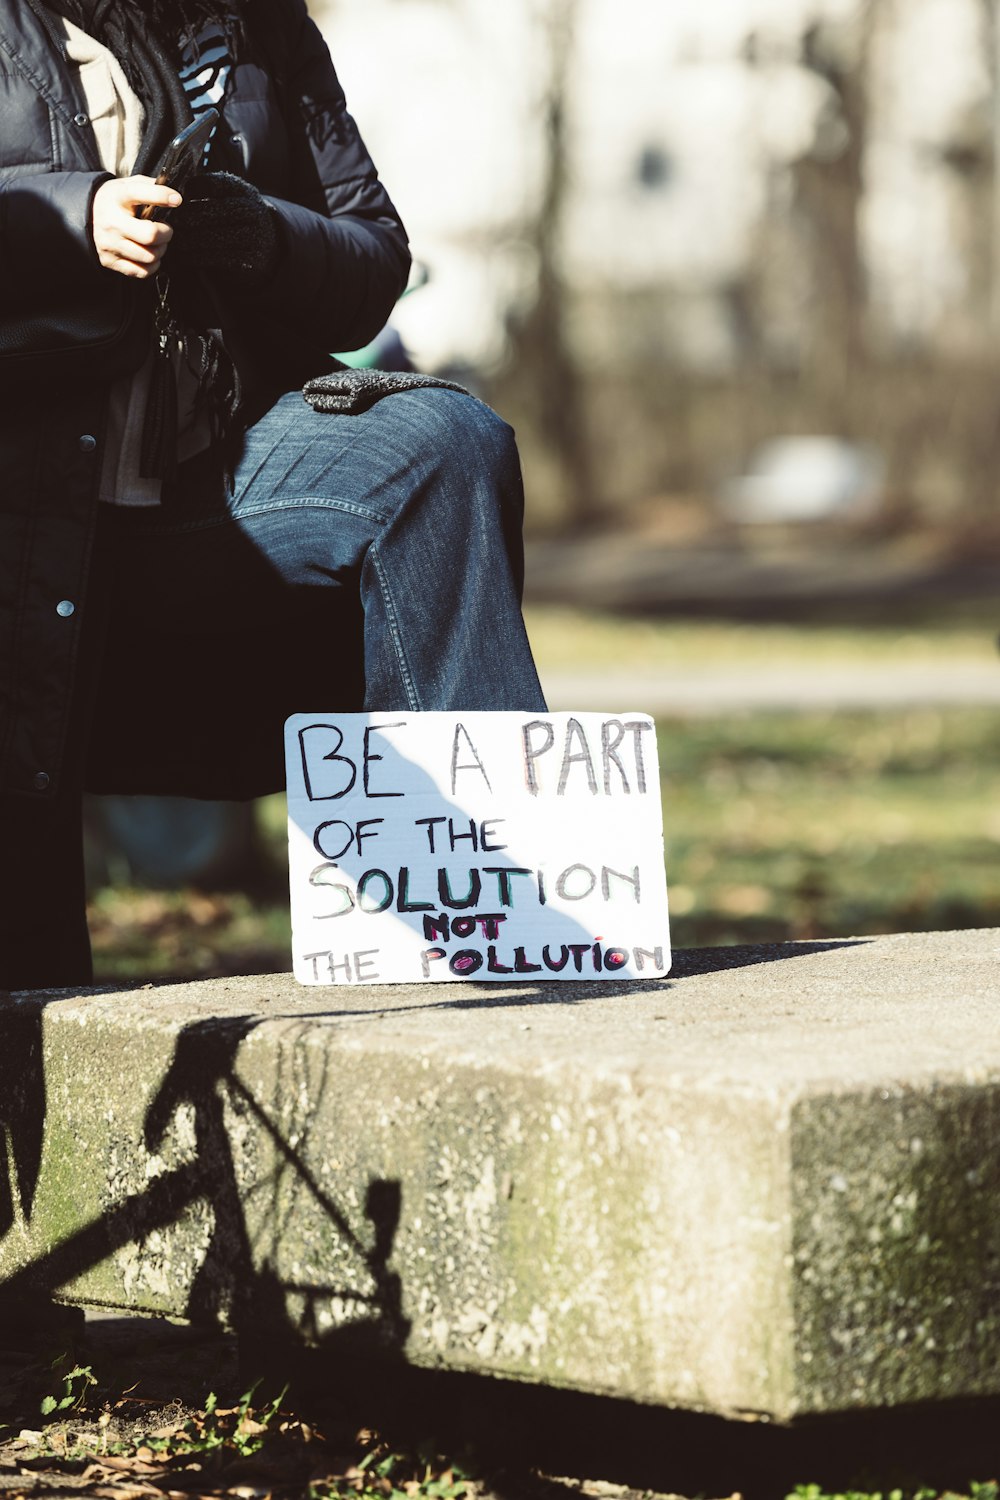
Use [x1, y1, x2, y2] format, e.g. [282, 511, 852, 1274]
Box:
[658, 708, 1000, 947]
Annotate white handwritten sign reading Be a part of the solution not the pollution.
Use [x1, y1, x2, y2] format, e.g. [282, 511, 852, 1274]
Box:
[285, 711, 670, 984]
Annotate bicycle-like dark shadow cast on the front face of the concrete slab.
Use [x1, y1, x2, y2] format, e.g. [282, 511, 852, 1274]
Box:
[0, 1001, 409, 1359]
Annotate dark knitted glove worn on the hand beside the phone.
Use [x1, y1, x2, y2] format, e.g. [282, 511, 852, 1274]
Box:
[166, 173, 282, 287]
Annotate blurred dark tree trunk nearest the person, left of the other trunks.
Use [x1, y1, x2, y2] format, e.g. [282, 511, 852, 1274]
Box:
[508, 0, 601, 525]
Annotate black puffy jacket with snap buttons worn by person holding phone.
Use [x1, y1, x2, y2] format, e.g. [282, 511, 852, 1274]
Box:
[0, 0, 409, 800]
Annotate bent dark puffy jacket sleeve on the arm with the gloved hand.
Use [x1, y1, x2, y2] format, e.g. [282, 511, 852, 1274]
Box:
[239, 0, 409, 350]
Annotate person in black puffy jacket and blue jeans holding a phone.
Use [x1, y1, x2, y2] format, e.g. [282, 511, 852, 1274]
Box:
[0, 0, 544, 990]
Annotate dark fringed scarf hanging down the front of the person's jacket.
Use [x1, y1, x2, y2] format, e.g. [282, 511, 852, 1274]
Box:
[28, 0, 240, 480]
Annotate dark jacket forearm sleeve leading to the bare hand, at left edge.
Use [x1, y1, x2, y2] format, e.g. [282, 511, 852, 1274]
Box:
[0, 173, 108, 300]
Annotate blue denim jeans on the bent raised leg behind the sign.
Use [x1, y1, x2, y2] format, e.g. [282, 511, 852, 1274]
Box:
[118, 390, 543, 710]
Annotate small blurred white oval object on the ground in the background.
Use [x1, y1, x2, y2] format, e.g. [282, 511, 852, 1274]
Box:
[720, 437, 885, 522]
